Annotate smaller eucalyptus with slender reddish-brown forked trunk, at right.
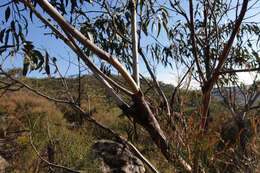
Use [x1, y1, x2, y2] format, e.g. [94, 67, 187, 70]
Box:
[169, 1, 259, 129]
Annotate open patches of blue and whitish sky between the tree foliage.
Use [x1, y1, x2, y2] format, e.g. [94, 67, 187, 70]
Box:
[0, 0, 260, 88]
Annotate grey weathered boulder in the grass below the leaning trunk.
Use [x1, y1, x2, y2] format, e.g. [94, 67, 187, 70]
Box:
[92, 140, 145, 173]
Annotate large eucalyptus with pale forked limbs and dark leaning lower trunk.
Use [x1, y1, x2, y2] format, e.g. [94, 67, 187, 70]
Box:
[1, 0, 177, 168]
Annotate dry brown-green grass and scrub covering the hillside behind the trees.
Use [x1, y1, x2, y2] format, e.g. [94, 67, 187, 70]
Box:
[0, 73, 259, 173]
